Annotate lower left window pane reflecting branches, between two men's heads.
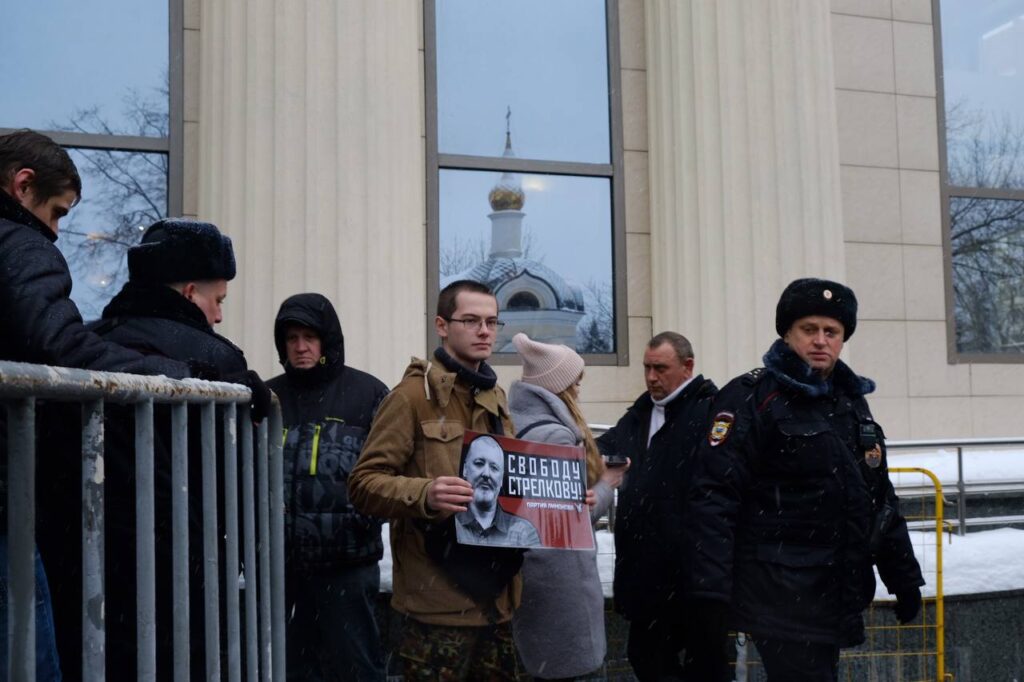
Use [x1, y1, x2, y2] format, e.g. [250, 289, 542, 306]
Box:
[57, 150, 167, 319]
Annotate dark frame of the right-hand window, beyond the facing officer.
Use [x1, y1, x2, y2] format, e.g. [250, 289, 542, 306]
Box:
[932, 0, 1024, 365]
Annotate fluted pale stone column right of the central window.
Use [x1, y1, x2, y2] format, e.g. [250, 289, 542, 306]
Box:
[645, 0, 845, 381]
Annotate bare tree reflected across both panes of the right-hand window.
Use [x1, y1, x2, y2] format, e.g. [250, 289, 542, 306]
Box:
[946, 101, 1024, 352]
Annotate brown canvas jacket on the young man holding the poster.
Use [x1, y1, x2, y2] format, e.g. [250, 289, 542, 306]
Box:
[348, 358, 520, 626]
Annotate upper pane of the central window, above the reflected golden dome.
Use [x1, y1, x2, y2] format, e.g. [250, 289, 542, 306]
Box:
[436, 0, 609, 163]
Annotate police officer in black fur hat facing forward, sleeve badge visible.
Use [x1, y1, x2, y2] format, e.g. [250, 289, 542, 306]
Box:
[687, 279, 924, 682]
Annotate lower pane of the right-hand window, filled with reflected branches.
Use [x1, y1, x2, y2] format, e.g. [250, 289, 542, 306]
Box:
[949, 192, 1024, 353]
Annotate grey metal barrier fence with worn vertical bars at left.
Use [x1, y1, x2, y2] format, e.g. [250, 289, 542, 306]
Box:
[0, 363, 285, 682]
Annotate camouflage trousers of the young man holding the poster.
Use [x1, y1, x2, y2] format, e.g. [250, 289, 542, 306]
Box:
[398, 619, 518, 682]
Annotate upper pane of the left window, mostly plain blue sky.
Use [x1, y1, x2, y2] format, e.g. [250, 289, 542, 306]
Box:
[0, 0, 169, 136]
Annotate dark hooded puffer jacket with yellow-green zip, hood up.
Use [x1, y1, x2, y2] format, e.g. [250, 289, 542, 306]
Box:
[267, 294, 387, 573]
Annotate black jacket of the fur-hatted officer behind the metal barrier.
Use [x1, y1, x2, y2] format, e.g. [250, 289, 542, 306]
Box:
[40, 282, 247, 679]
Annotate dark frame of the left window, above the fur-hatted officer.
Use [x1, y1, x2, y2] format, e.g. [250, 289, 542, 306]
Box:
[0, 0, 185, 216]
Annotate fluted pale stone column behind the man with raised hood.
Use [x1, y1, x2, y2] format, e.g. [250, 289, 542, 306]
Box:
[198, 0, 426, 383]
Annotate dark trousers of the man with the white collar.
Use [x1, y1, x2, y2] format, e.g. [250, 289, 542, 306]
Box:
[626, 620, 731, 682]
